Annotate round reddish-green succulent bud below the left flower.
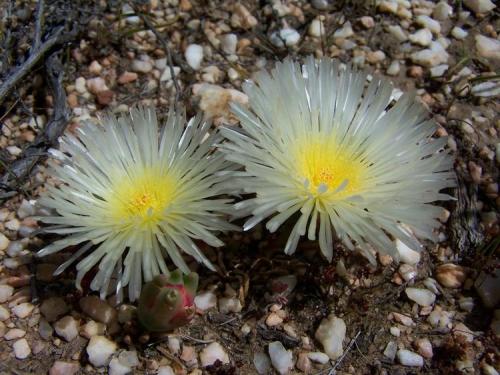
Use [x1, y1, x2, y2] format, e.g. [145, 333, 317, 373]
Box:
[137, 270, 198, 332]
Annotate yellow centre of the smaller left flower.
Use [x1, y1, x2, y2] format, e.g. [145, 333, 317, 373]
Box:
[106, 169, 175, 225]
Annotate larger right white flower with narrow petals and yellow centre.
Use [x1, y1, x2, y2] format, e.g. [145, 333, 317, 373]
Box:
[223, 57, 455, 261]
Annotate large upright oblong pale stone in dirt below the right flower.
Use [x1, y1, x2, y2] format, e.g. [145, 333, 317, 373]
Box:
[315, 314, 346, 360]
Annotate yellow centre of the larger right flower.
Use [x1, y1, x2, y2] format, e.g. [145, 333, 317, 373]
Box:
[296, 137, 366, 196]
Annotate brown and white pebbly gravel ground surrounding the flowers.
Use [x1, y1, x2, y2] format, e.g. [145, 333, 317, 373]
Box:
[0, 0, 500, 375]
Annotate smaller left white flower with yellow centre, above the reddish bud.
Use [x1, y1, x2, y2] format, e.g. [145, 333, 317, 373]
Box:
[38, 109, 235, 301]
